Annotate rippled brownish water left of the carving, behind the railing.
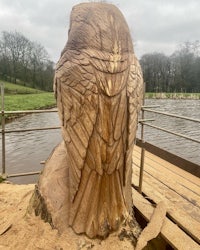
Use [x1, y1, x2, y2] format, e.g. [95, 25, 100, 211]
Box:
[0, 113, 61, 183]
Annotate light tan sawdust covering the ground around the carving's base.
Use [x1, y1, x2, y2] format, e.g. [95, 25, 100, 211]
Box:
[0, 183, 134, 250]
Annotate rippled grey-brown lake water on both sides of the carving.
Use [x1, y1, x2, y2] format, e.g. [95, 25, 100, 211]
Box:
[0, 99, 200, 183]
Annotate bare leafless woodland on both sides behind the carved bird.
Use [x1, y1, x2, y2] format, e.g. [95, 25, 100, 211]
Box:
[0, 31, 200, 93]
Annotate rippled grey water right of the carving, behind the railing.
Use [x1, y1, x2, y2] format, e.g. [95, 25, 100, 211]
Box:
[138, 99, 200, 165]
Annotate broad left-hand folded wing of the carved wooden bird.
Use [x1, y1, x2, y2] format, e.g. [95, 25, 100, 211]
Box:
[54, 51, 98, 201]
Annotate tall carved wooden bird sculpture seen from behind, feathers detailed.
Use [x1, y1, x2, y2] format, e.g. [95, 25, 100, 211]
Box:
[54, 3, 143, 237]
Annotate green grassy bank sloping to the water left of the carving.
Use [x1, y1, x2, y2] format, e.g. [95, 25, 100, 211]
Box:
[0, 81, 56, 124]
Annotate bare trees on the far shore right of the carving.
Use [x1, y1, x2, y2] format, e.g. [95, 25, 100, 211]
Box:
[140, 41, 200, 93]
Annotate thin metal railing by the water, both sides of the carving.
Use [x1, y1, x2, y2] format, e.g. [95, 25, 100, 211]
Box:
[0, 84, 200, 193]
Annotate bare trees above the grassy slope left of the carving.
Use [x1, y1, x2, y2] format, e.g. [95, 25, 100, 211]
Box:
[0, 31, 54, 91]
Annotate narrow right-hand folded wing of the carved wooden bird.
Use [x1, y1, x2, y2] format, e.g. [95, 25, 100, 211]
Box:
[125, 56, 144, 184]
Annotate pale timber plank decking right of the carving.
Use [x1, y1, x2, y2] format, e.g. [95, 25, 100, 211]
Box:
[132, 146, 200, 250]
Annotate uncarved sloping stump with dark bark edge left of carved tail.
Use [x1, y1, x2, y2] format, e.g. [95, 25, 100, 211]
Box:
[28, 142, 69, 233]
